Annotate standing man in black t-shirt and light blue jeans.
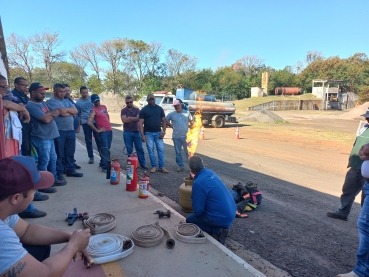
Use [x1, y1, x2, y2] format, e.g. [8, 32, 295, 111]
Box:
[138, 93, 169, 173]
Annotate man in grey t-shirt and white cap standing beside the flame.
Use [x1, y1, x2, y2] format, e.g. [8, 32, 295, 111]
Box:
[165, 100, 192, 172]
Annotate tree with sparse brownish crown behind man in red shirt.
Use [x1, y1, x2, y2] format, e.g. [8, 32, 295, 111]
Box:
[98, 38, 128, 93]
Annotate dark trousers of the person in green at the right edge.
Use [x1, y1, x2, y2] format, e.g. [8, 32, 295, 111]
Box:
[336, 167, 365, 217]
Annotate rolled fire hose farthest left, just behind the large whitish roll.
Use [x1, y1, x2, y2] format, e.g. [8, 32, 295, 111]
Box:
[83, 213, 117, 235]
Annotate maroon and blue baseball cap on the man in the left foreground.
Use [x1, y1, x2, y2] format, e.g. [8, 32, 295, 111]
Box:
[0, 156, 55, 197]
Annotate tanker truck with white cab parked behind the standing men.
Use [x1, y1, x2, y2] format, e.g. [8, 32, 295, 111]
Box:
[139, 93, 236, 128]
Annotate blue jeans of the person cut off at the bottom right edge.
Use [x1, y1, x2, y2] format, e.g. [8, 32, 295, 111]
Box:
[354, 182, 369, 277]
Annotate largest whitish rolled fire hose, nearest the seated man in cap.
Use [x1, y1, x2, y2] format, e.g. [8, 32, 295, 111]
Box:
[87, 234, 134, 264]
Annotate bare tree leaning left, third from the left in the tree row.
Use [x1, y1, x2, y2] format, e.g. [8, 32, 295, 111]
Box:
[71, 42, 101, 82]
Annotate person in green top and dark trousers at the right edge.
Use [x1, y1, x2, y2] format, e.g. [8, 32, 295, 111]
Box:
[327, 109, 369, 221]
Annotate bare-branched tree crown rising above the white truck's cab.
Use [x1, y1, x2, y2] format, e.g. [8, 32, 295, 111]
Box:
[166, 49, 197, 76]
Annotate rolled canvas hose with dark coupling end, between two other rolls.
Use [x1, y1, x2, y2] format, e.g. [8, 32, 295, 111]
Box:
[132, 222, 175, 249]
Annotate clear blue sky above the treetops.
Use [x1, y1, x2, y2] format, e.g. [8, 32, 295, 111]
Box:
[0, 0, 369, 70]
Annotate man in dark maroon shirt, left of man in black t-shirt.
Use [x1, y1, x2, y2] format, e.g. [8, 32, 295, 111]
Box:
[120, 95, 149, 169]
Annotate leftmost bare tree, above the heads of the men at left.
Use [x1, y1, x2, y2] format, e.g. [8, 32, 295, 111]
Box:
[6, 33, 35, 83]
